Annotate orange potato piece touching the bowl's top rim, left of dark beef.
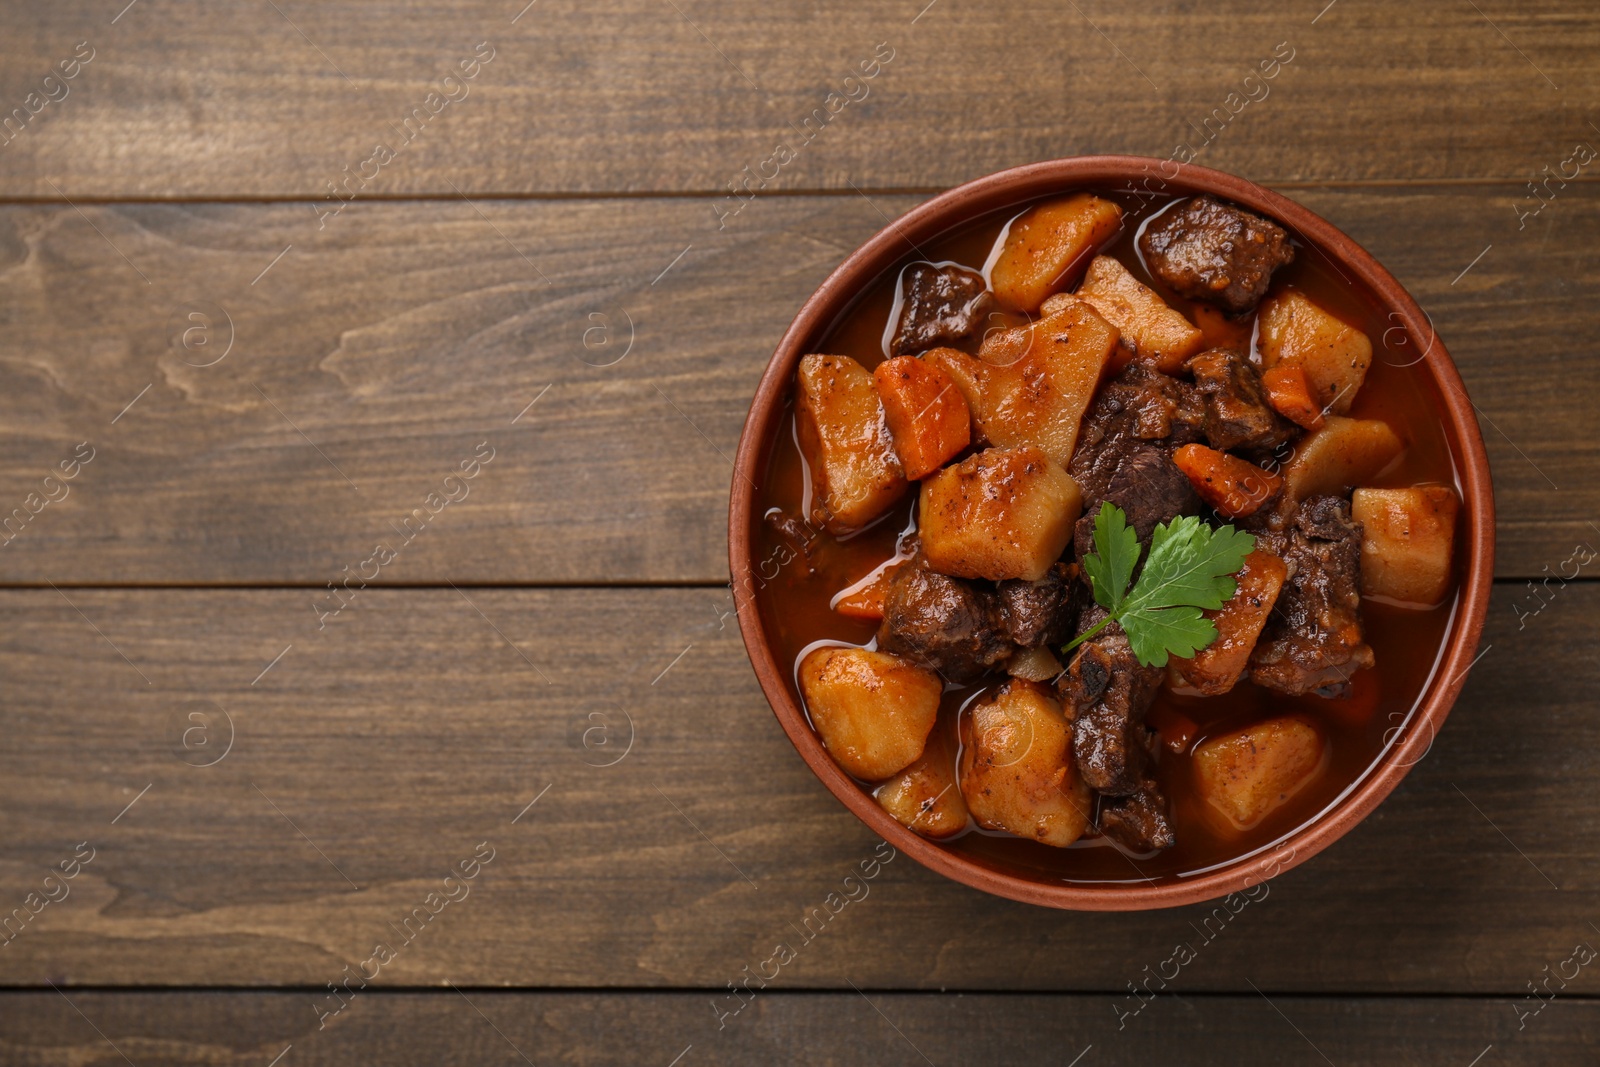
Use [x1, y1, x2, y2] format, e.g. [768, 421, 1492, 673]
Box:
[989, 192, 1122, 312]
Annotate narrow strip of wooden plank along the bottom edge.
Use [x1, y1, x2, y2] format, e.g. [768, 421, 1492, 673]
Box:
[0, 990, 1600, 1067]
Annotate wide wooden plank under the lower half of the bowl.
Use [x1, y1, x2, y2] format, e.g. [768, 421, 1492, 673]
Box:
[0, 582, 1600, 991]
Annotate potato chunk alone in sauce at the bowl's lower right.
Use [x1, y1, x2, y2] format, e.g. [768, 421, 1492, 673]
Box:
[1194, 715, 1326, 830]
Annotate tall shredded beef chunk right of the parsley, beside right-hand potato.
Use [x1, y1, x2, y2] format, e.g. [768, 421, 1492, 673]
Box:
[1250, 496, 1373, 696]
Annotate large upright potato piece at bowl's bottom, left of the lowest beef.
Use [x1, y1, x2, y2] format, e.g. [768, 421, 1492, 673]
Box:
[962, 678, 1091, 848]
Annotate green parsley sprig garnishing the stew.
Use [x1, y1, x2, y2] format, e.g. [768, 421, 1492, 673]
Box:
[1061, 504, 1256, 667]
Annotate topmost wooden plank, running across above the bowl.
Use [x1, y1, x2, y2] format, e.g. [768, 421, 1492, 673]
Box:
[0, 0, 1600, 198]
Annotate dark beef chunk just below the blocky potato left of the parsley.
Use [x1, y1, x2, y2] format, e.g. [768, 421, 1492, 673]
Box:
[878, 560, 1016, 681]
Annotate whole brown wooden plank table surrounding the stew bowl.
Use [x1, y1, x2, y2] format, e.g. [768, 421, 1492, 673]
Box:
[0, 0, 1600, 1067]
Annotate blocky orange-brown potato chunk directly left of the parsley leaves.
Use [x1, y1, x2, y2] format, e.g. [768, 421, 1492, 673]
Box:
[918, 445, 1083, 582]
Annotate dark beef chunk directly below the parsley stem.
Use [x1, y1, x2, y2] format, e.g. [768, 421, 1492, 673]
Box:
[1058, 608, 1165, 797]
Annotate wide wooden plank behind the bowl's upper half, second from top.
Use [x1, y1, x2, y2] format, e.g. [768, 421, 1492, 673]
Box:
[0, 184, 1600, 585]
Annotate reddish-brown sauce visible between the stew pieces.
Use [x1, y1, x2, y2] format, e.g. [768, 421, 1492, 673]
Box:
[752, 190, 1461, 883]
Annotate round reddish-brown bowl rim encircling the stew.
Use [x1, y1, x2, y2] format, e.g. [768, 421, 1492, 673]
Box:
[728, 155, 1494, 912]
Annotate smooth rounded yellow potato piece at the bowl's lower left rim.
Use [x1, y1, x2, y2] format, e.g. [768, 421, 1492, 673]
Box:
[800, 648, 944, 779]
